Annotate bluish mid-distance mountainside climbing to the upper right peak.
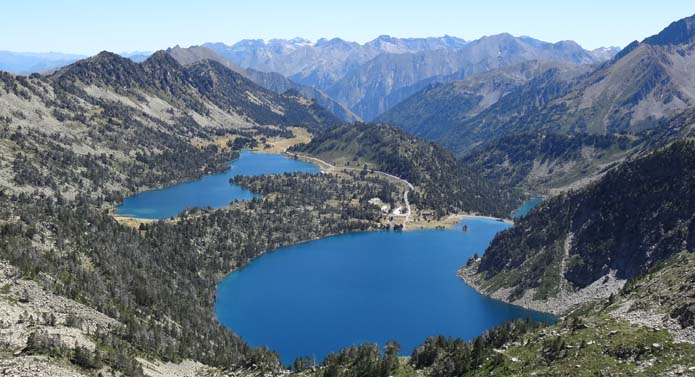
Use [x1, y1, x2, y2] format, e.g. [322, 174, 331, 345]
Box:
[378, 17, 695, 154]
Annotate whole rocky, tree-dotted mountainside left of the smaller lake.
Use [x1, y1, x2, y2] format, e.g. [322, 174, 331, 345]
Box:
[0, 52, 339, 200]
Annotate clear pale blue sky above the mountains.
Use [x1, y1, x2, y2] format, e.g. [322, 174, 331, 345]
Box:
[0, 0, 695, 54]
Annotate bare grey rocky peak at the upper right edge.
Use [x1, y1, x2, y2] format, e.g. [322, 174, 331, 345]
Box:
[544, 16, 695, 137]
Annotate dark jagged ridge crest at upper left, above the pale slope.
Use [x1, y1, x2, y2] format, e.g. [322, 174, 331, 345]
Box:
[52, 51, 337, 127]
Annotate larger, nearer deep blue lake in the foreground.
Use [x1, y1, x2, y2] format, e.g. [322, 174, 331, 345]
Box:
[216, 219, 553, 363]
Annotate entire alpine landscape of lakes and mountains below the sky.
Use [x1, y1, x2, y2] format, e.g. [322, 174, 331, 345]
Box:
[0, 7, 695, 377]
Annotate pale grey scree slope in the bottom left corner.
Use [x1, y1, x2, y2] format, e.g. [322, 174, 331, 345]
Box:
[0, 261, 227, 377]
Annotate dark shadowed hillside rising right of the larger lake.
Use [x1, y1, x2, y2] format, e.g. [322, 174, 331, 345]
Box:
[464, 141, 695, 301]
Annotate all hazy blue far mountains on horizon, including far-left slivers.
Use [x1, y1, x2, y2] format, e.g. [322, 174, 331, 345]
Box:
[0, 34, 618, 122]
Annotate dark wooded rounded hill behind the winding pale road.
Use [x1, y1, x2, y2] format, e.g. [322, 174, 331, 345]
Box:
[292, 124, 519, 217]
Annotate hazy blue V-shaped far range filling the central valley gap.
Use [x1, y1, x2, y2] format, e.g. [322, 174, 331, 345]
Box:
[204, 34, 617, 120]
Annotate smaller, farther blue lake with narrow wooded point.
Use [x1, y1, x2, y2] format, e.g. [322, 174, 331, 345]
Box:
[116, 151, 320, 219]
